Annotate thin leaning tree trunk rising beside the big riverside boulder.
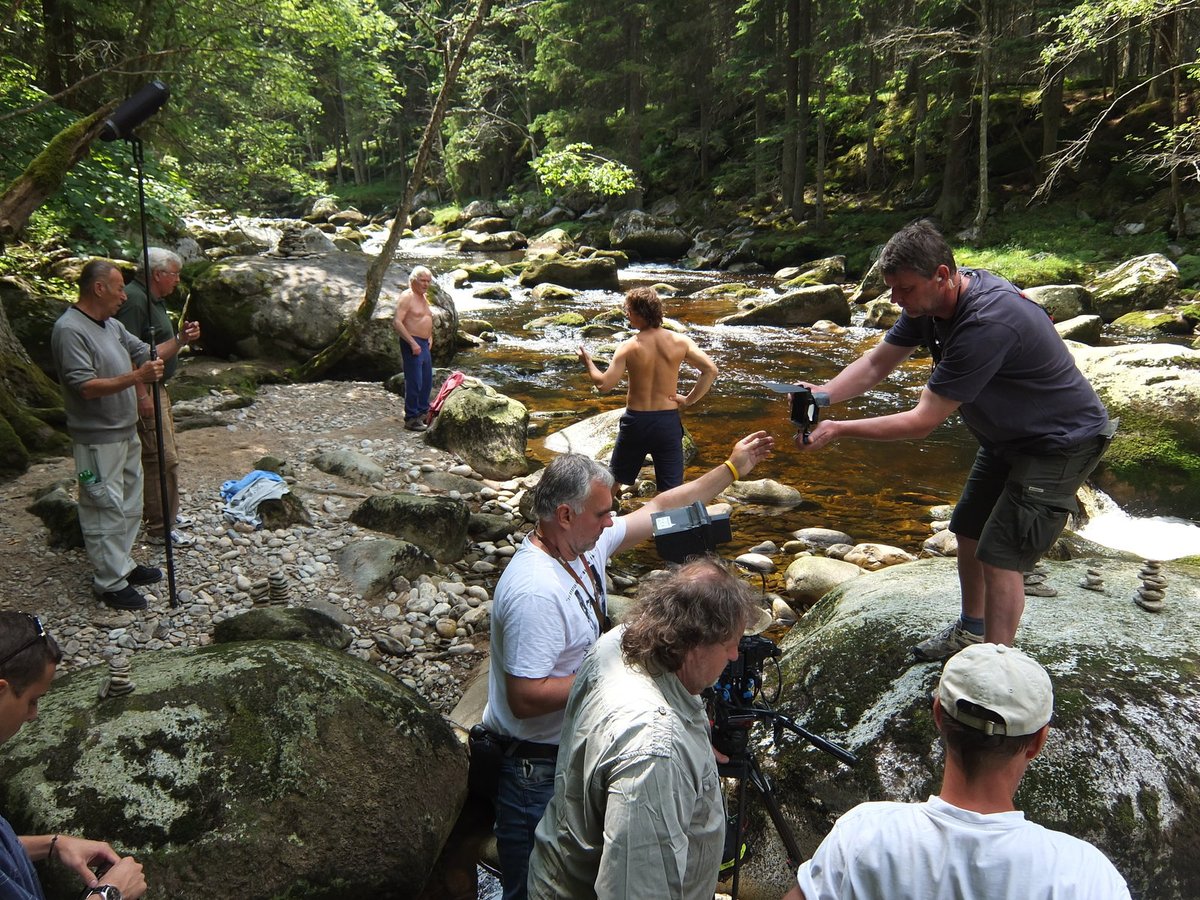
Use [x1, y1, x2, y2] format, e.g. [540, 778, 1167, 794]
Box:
[288, 0, 491, 382]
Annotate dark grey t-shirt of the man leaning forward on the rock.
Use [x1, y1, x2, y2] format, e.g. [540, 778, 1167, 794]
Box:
[883, 269, 1109, 454]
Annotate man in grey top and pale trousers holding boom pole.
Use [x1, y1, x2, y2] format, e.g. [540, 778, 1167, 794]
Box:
[50, 259, 187, 610]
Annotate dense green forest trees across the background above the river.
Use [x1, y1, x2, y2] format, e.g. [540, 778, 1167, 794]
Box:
[0, 0, 1200, 252]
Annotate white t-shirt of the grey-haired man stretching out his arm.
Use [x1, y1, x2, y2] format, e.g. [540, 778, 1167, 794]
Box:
[484, 517, 625, 744]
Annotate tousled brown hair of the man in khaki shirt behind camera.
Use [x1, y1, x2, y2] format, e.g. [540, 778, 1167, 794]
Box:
[620, 556, 755, 673]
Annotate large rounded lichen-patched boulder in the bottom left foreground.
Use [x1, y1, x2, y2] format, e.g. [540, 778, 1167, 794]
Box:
[0, 641, 467, 900]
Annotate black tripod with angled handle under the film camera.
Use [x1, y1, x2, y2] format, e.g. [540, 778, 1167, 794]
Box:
[714, 700, 858, 900]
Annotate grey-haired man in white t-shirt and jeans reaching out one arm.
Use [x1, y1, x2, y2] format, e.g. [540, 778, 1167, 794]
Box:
[484, 431, 774, 900]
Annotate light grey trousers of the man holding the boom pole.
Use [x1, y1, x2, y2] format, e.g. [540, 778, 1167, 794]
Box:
[74, 433, 142, 593]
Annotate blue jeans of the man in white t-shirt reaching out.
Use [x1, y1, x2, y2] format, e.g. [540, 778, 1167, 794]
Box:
[496, 756, 554, 900]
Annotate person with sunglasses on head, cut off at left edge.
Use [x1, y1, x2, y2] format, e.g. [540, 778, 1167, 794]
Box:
[0, 612, 146, 900]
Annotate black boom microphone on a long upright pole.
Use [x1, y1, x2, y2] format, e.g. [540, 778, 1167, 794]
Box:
[100, 79, 179, 607]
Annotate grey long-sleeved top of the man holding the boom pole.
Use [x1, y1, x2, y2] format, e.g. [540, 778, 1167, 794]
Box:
[50, 306, 150, 444]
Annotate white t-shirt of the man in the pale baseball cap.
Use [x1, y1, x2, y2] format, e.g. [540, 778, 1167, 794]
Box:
[797, 797, 1129, 900]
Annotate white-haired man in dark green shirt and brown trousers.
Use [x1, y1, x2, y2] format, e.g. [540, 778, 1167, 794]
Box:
[116, 247, 200, 547]
